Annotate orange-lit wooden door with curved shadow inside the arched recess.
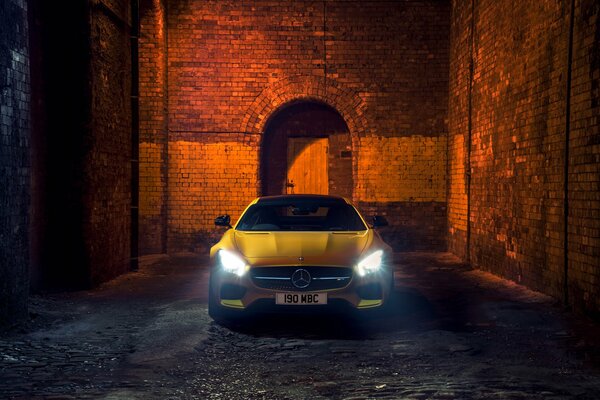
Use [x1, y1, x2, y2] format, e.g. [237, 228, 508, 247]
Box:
[286, 137, 329, 194]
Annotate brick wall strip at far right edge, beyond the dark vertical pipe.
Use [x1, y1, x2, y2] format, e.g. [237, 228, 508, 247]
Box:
[568, 0, 600, 316]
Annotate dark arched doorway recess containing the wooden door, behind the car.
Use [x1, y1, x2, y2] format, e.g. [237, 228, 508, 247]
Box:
[260, 100, 353, 198]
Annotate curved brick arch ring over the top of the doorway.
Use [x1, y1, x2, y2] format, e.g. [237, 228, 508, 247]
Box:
[241, 75, 367, 137]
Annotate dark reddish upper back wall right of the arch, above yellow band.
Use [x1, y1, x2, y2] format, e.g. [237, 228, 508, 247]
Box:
[325, 1, 449, 136]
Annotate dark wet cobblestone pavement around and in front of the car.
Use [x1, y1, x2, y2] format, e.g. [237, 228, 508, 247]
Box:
[0, 253, 600, 399]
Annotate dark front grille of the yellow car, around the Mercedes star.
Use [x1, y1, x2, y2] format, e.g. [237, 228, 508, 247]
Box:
[250, 266, 352, 291]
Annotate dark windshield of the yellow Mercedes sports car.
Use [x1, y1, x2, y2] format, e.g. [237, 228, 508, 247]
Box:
[236, 202, 367, 231]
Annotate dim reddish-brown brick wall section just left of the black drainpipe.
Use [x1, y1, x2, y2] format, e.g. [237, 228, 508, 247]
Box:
[83, 0, 131, 285]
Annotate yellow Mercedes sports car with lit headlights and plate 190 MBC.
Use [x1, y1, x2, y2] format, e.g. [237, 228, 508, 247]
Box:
[208, 195, 394, 322]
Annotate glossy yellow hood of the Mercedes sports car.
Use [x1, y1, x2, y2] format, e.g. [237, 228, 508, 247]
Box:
[235, 231, 372, 265]
